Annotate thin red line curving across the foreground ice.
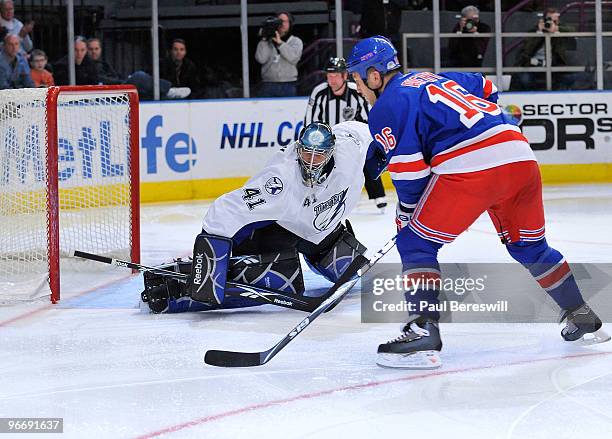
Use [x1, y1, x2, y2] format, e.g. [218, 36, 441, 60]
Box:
[136, 352, 612, 439]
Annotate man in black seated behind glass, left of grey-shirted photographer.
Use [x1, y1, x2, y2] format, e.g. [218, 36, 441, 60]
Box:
[159, 38, 200, 96]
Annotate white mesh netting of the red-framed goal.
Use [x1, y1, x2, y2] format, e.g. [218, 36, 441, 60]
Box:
[0, 89, 132, 302]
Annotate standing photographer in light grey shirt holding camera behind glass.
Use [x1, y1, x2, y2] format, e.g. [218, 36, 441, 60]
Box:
[255, 12, 303, 97]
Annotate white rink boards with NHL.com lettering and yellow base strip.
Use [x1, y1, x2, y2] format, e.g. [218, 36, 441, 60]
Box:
[140, 92, 612, 202]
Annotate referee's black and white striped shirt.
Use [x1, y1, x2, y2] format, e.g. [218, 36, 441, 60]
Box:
[304, 81, 370, 126]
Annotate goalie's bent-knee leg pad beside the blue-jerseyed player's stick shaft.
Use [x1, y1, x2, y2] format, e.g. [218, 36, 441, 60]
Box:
[304, 230, 367, 282]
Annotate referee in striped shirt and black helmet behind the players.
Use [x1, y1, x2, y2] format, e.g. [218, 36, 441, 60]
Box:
[304, 58, 387, 211]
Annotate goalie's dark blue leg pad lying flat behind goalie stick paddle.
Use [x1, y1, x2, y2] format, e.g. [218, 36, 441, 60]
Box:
[228, 249, 305, 295]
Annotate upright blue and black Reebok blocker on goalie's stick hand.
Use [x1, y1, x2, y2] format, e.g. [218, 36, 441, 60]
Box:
[187, 233, 232, 305]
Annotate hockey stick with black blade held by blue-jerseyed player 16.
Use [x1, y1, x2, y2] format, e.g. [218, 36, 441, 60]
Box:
[204, 235, 397, 367]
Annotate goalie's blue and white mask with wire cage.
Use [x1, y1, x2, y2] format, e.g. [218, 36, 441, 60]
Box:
[296, 122, 336, 187]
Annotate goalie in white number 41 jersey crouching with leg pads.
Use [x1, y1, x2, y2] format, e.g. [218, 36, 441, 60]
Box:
[143, 121, 372, 312]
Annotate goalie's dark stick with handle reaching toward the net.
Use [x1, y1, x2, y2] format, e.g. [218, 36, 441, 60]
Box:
[71, 250, 326, 312]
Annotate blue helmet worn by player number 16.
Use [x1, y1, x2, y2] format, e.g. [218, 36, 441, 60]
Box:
[346, 35, 401, 82]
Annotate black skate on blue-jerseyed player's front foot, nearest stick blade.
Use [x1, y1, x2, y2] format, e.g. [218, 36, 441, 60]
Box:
[376, 315, 442, 369]
